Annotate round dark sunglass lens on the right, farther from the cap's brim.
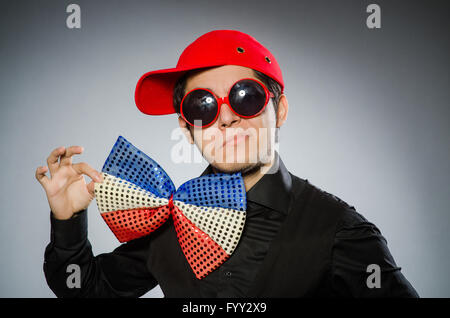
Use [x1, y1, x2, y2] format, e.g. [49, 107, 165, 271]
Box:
[229, 79, 266, 117]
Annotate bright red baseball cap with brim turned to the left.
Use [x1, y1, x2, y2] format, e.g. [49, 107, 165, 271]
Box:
[134, 30, 284, 115]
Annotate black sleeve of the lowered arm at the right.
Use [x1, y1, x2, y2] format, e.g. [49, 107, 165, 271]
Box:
[331, 209, 419, 298]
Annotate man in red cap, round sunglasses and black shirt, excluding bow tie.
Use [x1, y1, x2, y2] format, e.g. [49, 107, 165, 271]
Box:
[36, 30, 418, 297]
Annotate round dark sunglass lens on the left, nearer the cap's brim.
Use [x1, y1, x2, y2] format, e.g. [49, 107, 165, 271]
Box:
[182, 89, 218, 126]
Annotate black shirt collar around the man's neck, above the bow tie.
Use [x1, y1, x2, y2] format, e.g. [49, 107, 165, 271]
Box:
[201, 153, 292, 214]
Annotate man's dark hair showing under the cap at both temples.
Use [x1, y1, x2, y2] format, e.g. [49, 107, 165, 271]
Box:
[173, 69, 281, 115]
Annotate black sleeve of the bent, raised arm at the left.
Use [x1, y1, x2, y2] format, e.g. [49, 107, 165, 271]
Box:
[43, 209, 157, 298]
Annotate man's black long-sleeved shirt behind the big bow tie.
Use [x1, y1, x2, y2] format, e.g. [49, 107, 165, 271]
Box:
[44, 157, 418, 297]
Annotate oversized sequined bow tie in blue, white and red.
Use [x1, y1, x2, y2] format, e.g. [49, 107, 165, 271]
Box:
[95, 136, 247, 279]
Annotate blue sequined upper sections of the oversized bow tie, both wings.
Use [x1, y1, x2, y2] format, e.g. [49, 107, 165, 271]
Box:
[102, 136, 247, 211]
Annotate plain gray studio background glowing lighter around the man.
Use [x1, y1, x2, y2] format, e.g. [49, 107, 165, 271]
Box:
[0, 0, 450, 297]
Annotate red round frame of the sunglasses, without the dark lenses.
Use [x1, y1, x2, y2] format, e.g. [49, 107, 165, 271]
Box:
[180, 77, 275, 128]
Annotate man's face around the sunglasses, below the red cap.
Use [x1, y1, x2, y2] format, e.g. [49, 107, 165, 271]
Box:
[179, 65, 284, 173]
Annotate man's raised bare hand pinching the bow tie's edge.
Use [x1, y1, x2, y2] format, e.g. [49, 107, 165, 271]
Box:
[36, 146, 103, 220]
